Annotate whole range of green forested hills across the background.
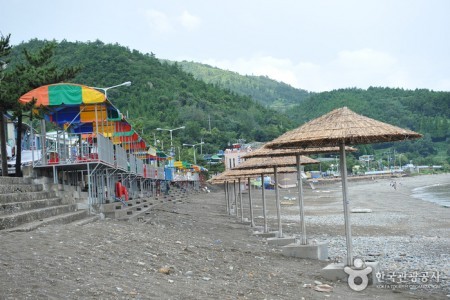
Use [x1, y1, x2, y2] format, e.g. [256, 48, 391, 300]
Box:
[4, 40, 450, 165]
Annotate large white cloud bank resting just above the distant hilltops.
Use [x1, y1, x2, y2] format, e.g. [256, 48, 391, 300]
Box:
[202, 48, 414, 92]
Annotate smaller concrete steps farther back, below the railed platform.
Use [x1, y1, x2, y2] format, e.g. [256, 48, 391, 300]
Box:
[102, 187, 188, 221]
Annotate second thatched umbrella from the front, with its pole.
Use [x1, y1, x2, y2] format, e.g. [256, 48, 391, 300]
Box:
[242, 145, 356, 245]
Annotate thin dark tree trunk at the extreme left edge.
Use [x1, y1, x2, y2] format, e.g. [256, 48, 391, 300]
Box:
[0, 34, 11, 176]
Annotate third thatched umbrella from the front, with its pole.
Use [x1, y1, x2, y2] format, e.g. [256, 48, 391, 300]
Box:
[235, 156, 319, 238]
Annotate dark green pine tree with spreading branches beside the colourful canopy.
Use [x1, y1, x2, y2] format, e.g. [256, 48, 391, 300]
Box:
[4, 42, 81, 176]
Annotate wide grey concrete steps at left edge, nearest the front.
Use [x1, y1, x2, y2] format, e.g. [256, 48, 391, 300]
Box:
[0, 176, 88, 231]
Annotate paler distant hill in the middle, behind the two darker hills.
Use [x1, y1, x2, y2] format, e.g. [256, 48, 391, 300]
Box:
[172, 61, 310, 112]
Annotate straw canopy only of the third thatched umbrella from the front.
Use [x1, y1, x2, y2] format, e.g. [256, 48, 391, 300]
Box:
[234, 156, 319, 173]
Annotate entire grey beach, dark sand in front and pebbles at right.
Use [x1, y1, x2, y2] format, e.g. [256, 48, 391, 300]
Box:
[0, 174, 450, 299]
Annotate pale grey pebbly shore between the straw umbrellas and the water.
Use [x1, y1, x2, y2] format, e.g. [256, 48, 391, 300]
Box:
[258, 174, 450, 298]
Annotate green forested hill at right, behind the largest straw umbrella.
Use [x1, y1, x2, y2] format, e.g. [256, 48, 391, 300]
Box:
[288, 87, 450, 165]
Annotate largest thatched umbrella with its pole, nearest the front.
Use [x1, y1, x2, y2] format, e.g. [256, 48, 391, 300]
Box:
[266, 107, 422, 266]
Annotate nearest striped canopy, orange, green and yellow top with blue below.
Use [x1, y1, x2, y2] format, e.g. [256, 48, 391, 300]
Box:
[19, 83, 147, 152]
